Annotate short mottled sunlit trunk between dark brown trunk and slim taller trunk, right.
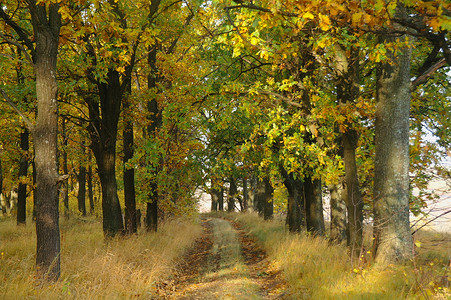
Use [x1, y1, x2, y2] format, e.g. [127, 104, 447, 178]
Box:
[329, 177, 347, 243]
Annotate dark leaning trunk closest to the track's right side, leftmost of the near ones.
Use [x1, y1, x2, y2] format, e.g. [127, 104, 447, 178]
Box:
[280, 167, 305, 232]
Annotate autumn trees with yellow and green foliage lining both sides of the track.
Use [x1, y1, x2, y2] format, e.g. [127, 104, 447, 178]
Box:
[0, 0, 451, 279]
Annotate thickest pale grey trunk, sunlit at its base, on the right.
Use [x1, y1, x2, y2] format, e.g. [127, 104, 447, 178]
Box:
[373, 12, 412, 265]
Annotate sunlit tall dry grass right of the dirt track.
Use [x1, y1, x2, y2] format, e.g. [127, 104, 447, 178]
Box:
[233, 214, 451, 299]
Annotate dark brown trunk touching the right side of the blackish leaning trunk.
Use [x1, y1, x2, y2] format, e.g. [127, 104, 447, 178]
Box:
[304, 177, 325, 236]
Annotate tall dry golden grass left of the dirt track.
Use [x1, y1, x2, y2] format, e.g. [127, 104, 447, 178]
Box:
[0, 214, 202, 299]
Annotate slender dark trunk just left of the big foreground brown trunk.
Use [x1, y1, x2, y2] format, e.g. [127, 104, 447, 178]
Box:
[17, 128, 29, 225]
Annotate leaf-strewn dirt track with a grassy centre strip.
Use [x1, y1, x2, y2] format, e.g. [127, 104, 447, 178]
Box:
[158, 218, 289, 299]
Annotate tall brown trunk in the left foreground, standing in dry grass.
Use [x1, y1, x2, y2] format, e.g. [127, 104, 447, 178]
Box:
[28, 1, 61, 280]
